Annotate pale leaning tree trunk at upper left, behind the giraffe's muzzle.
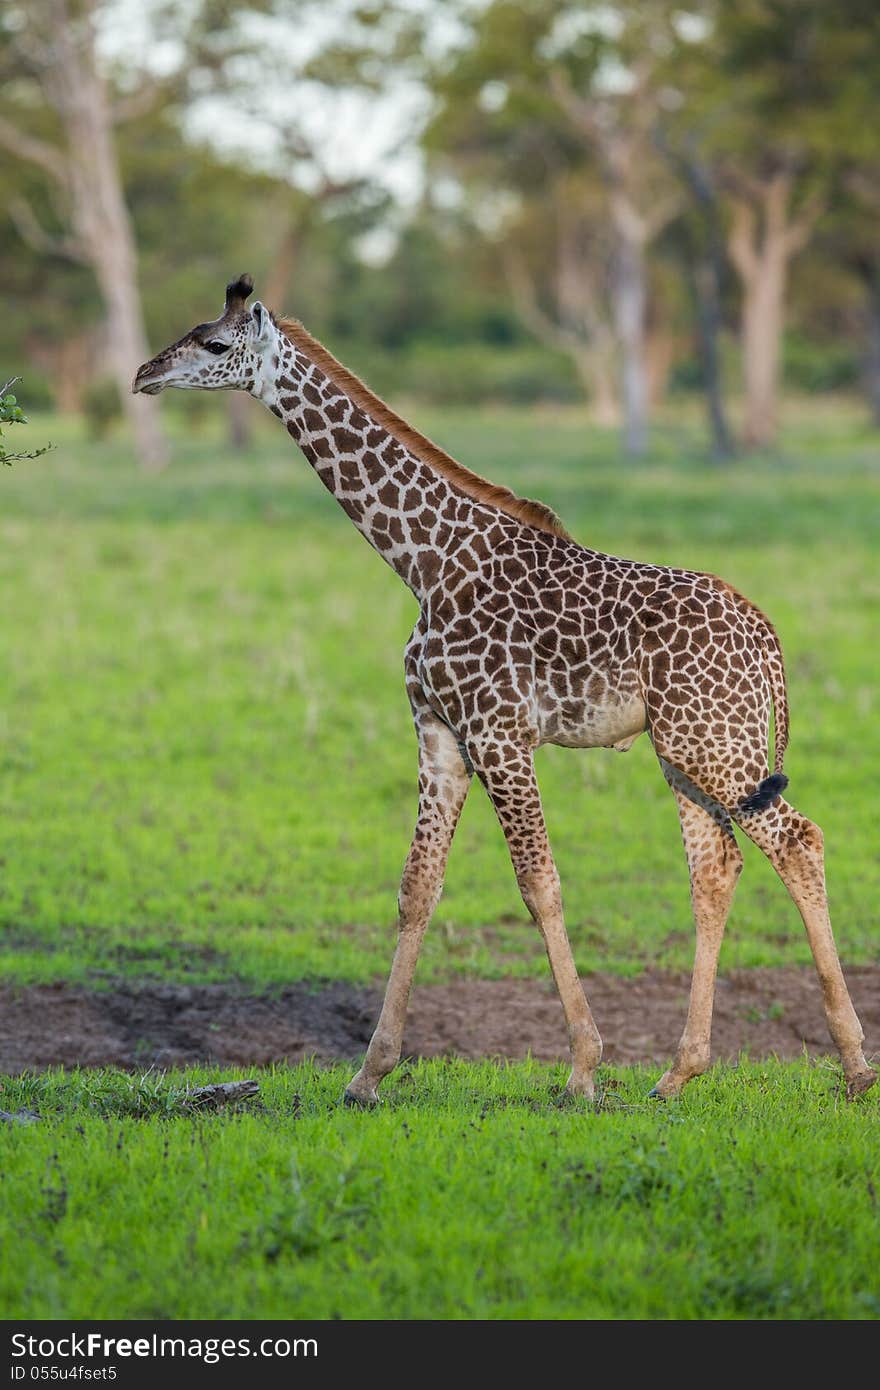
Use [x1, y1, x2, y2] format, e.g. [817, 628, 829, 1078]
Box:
[42, 0, 168, 468]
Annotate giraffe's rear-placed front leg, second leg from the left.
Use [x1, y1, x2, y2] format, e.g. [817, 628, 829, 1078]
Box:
[468, 744, 602, 1097]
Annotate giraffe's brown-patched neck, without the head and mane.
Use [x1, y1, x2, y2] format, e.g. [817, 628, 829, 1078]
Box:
[252, 335, 500, 600]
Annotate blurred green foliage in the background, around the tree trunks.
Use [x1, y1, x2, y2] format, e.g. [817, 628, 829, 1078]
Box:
[0, 0, 880, 427]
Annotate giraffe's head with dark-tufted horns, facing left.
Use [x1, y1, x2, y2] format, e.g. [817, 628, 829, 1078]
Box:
[132, 275, 275, 396]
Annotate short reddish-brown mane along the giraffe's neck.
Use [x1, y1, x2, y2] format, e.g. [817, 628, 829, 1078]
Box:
[275, 318, 571, 541]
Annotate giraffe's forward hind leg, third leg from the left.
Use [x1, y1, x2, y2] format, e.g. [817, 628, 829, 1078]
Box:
[651, 762, 742, 1099]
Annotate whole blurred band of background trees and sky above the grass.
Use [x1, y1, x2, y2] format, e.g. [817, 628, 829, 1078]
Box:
[0, 0, 880, 456]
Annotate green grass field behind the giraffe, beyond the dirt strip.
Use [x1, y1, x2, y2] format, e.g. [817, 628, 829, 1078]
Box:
[0, 407, 880, 986]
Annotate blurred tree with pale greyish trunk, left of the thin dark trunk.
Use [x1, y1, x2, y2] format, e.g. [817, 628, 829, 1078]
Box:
[425, 0, 680, 453]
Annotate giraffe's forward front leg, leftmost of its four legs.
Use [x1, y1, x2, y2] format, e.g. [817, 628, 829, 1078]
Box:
[345, 713, 470, 1105]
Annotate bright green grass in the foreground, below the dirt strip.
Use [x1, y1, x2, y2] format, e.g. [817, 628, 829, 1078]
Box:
[0, 1062, 880, 1319]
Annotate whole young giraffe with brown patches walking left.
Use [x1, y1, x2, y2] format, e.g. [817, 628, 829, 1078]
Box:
[132, 275, 877, 1105]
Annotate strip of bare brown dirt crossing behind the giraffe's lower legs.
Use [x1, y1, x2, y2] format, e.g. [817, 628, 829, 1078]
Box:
[0, 967, 880, 1074]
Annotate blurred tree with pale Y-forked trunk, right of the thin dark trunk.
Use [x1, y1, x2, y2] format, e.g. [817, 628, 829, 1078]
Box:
[683, 0, 880, 445]
